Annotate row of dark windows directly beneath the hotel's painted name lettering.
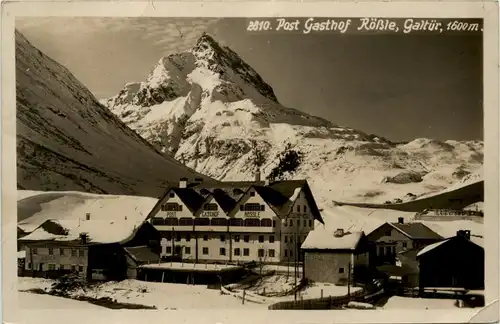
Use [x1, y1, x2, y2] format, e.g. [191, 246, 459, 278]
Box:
[152, 217, 276, 227]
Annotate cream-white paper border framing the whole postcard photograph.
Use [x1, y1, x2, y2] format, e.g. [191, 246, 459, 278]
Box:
[1, 1, 500, 324]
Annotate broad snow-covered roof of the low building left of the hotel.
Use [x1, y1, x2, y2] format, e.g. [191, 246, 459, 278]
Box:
[20, 217, 145, 244]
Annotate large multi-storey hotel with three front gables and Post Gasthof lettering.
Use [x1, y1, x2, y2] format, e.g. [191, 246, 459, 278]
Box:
[149, 178, 323, 263]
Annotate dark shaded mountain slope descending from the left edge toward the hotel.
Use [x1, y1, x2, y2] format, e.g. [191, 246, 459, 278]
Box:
[16, 31, 212, 197]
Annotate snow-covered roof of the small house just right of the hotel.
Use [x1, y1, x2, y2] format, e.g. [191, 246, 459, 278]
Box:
[301, 225, 364, 250]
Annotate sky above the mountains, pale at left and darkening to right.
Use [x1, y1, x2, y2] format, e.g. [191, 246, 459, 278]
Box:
[16, 17, 483, 141]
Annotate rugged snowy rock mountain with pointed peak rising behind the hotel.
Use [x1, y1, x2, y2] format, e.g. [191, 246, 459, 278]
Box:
[102, 34, 483, 202]
